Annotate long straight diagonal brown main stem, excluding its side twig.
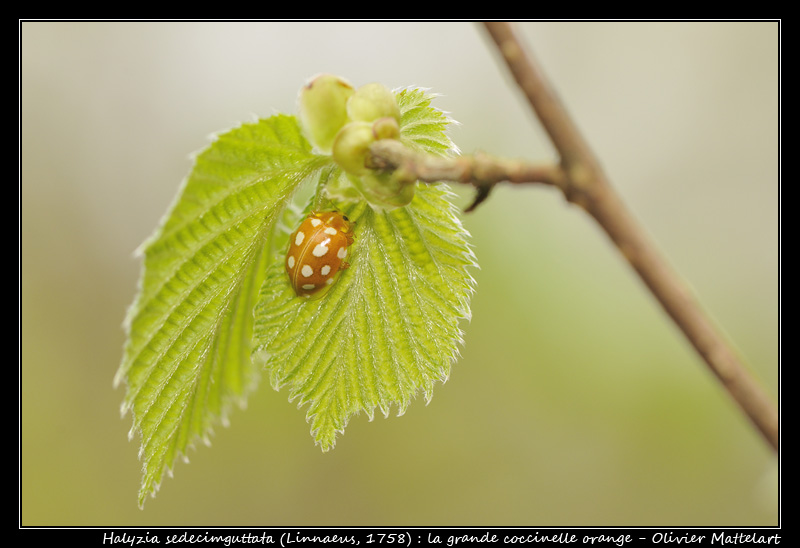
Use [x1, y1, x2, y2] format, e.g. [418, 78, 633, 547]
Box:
[485, 23, 780, 451]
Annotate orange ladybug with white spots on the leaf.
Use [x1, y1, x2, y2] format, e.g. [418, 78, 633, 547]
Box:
[286, 211, 355, 297]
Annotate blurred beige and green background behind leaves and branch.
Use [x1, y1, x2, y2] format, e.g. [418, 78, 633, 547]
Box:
[20, 22, 780, 526]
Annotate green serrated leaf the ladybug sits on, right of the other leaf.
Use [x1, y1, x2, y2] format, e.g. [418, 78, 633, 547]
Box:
[253, 90, 475, 451]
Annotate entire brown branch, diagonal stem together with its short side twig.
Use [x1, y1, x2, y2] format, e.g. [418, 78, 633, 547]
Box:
[371, 23, 780, 451]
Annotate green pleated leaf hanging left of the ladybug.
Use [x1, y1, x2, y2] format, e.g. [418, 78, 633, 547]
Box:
[115, 116, 328, 505]
